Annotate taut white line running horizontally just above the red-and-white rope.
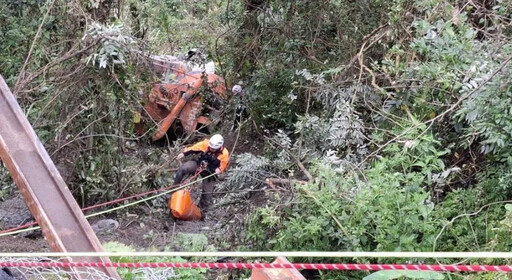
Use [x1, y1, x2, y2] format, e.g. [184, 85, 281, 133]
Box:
[0, 251, 512, 259]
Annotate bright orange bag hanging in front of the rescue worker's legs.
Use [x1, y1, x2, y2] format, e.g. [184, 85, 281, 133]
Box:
[168, 190, 201, 221]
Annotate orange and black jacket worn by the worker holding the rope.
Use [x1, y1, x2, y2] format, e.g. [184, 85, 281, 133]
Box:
[183, 139, 229, 173]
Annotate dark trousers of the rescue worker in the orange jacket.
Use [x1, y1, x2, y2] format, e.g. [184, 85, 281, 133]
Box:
[174, 160, 215, 209]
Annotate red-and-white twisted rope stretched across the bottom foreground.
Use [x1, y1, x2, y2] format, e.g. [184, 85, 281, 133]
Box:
[0, 262, 512, 272]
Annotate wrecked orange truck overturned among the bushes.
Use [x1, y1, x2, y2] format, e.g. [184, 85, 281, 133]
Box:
[136, 55, 227, 141]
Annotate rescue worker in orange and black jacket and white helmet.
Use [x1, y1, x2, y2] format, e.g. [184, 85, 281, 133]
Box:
[174, 134, 229, 209]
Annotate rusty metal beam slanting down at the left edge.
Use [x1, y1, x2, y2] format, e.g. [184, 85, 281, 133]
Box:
[0, 75, 120, 279]
